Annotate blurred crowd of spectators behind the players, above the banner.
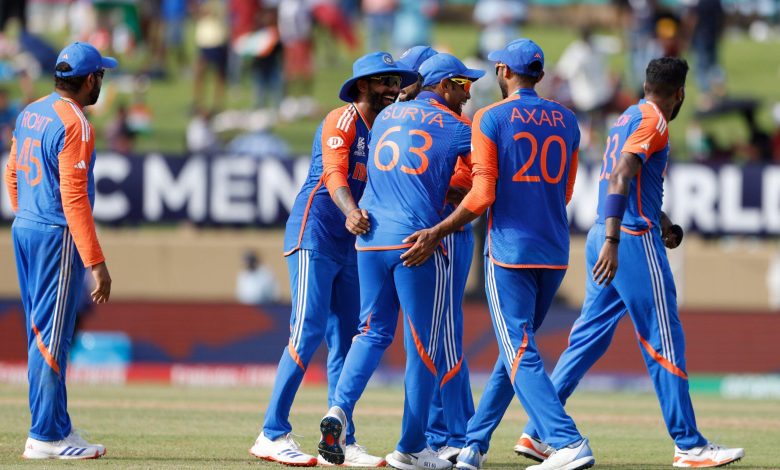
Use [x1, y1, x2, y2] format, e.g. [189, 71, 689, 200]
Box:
[0, 0, 780, 162]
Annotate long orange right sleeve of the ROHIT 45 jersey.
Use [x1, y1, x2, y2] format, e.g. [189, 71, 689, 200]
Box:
[53, 100, 105, 267]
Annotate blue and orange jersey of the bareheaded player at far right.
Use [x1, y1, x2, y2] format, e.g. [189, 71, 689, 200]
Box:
[598, 100, 669, 235]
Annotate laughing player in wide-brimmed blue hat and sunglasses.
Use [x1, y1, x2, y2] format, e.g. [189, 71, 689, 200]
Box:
[250, 52, 417, 467]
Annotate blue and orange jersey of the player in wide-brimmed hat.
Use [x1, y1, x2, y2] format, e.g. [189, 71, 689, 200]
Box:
[284, 104, 371, 265]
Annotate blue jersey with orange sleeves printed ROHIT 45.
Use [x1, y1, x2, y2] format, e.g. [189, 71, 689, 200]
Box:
[5, 93, 105, 266]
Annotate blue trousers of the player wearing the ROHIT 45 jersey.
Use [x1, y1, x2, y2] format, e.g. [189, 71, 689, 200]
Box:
[11, 219, 85, 441]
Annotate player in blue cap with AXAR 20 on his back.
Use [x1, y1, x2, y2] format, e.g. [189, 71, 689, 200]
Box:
[404, 39, 595, 470]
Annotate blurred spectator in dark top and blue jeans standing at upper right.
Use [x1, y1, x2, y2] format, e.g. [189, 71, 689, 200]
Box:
[685, 0, 726, 110]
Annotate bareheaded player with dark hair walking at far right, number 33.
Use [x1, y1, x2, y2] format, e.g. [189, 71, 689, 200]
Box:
[516, 57, 745, 467]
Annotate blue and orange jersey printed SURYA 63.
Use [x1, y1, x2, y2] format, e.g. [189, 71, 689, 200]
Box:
[357, 92, 471, 250]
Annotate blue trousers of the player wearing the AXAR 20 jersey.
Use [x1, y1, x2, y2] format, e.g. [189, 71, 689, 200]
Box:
[467, 258, 582, 453]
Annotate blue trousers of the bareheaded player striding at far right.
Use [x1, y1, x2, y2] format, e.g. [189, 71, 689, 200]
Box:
[526, 224, 707, 450]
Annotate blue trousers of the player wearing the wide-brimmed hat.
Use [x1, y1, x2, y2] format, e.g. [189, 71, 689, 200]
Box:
[263, 250, 360, 444]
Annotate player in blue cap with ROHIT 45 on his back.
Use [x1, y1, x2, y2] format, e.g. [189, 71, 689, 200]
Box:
[5, 42, 117, 459]
